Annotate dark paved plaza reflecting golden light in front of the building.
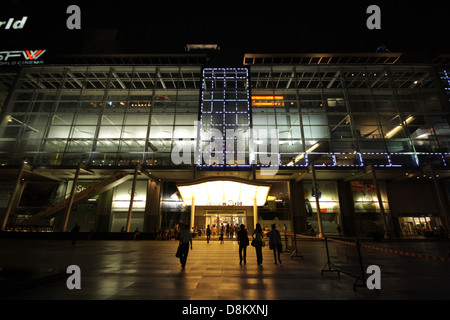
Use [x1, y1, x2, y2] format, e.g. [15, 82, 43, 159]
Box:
[0, 239, 450, 300]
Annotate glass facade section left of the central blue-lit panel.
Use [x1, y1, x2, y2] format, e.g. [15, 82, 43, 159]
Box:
[0, 66, 201, 166]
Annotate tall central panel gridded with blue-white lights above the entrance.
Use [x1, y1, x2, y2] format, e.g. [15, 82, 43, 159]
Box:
[197, 68, 251, 167]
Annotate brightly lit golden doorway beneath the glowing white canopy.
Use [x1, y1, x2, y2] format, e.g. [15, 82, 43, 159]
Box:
[205, 210, 247, 239]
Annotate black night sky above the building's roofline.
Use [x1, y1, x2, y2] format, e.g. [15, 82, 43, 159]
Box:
[0, 0, 450, 62]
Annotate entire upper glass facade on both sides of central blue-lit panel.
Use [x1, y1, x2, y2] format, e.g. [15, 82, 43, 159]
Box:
[0, 65, 450, 167]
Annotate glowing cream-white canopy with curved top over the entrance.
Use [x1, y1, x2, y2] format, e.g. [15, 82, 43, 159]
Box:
[178, 179, 270, 206]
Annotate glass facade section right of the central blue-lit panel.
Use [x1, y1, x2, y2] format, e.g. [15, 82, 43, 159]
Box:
[251, 65, 449, 167]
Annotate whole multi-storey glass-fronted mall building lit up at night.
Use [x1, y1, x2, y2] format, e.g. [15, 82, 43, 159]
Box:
[0, 50, 450, 237]
